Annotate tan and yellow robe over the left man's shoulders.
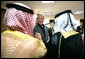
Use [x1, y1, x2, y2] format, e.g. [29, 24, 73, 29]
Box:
[1, 30, 47, 58]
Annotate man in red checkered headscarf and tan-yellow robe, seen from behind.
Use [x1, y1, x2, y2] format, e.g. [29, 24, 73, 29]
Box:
[1, 3, 47, 58]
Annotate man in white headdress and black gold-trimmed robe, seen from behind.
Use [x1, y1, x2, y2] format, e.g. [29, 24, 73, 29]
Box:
[52, 10, 83, 58]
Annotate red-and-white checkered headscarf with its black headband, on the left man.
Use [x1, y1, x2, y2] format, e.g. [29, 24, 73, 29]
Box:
[4, 3, 35, 36]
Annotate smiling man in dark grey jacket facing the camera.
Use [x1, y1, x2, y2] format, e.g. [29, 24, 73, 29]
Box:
[33, 14, 49, 46]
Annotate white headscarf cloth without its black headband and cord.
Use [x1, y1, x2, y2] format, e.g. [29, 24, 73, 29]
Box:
[54, 13, 77, 33]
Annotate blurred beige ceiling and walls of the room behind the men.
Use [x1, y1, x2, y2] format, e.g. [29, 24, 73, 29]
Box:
[1, 1, 84, 32]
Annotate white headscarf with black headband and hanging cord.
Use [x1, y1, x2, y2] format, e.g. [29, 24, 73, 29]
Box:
[54, 10, 77, 33]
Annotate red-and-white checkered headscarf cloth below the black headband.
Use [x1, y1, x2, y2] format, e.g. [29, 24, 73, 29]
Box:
[4, 8, 34, 36]
